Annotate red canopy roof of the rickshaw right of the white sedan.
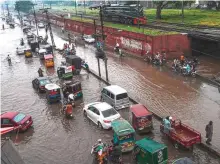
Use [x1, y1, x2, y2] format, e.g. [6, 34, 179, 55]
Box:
[130, 104, 152, 117]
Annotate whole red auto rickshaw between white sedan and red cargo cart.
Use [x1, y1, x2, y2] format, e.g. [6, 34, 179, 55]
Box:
[130, 104, 153, 133]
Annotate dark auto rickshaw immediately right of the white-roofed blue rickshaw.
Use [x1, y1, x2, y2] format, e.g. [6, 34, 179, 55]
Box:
[62, 81, 83, 99]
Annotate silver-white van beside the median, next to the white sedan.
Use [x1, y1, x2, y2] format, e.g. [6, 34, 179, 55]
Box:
[101, 85, 130, 110]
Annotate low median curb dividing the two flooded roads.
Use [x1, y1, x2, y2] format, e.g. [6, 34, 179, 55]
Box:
[83, 68, 220, 157]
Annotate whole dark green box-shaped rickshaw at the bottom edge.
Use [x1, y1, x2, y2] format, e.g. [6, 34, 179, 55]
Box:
[132, 138, 168, 164]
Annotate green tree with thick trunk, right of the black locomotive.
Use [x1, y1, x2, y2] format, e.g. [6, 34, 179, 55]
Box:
[153, 0, 195, 19]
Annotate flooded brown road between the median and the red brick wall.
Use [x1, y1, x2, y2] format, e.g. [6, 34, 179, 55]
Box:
[50, 27, 220, 148]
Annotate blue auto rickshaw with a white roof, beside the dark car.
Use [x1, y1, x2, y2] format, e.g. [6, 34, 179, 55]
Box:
[45, 84, 61, 103]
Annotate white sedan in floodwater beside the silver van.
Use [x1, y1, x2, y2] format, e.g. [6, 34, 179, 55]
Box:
[83, 102, 121, 129]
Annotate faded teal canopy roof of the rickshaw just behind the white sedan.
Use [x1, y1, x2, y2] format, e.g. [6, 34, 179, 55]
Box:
[111, 119, 135, 136]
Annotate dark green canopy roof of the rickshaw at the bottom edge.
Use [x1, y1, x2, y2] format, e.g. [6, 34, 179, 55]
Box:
[135, 138, 166, 154]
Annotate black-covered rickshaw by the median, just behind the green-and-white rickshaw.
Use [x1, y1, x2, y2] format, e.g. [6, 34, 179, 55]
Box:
[66, 55, 82, 75]
